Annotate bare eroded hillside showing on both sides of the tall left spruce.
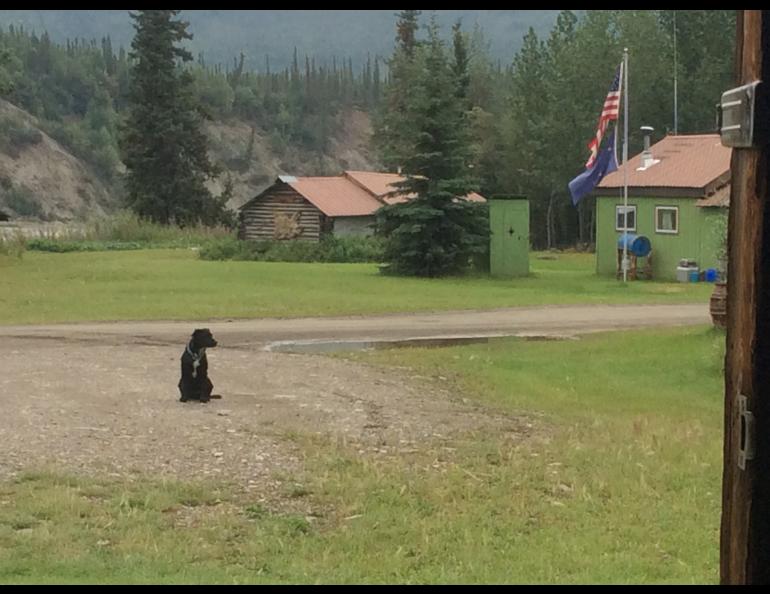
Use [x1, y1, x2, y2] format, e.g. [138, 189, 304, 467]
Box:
[0, 99, 378, 221]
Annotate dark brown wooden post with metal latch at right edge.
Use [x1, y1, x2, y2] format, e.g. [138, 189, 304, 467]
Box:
[714, 10, 770, 584]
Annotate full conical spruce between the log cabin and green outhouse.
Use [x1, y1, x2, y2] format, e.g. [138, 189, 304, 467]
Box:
[378, 21, 488, 277]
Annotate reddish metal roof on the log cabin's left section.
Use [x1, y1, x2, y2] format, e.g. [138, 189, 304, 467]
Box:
[288, 176, 382, 217]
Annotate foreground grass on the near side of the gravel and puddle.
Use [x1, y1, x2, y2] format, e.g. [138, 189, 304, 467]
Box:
[0, 328, 724, 584]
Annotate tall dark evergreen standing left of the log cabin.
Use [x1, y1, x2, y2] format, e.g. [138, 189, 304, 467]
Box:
[121, 10, 227, 225]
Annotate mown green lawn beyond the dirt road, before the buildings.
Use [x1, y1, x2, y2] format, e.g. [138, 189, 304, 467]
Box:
[0, 250, 712, 324]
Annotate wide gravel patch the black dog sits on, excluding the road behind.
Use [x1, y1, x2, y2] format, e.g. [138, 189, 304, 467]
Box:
[0, 338, 529, 505]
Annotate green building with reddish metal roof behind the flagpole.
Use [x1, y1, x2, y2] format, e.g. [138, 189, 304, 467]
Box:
[594, 134, 731, 281]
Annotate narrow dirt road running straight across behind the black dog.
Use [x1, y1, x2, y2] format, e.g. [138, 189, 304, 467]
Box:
[0, 303, 709, 346]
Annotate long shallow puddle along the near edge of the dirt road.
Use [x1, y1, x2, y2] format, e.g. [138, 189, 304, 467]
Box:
[265, 334, 577, 354]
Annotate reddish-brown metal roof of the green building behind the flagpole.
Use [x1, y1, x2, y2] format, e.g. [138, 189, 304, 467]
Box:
[598, 134, 732, 192]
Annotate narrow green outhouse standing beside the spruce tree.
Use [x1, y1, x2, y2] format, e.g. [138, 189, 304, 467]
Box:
[489, 195, 529, 277]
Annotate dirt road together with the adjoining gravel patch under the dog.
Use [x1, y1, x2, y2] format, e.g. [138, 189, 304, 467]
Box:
[0, 305, 708, 502]
